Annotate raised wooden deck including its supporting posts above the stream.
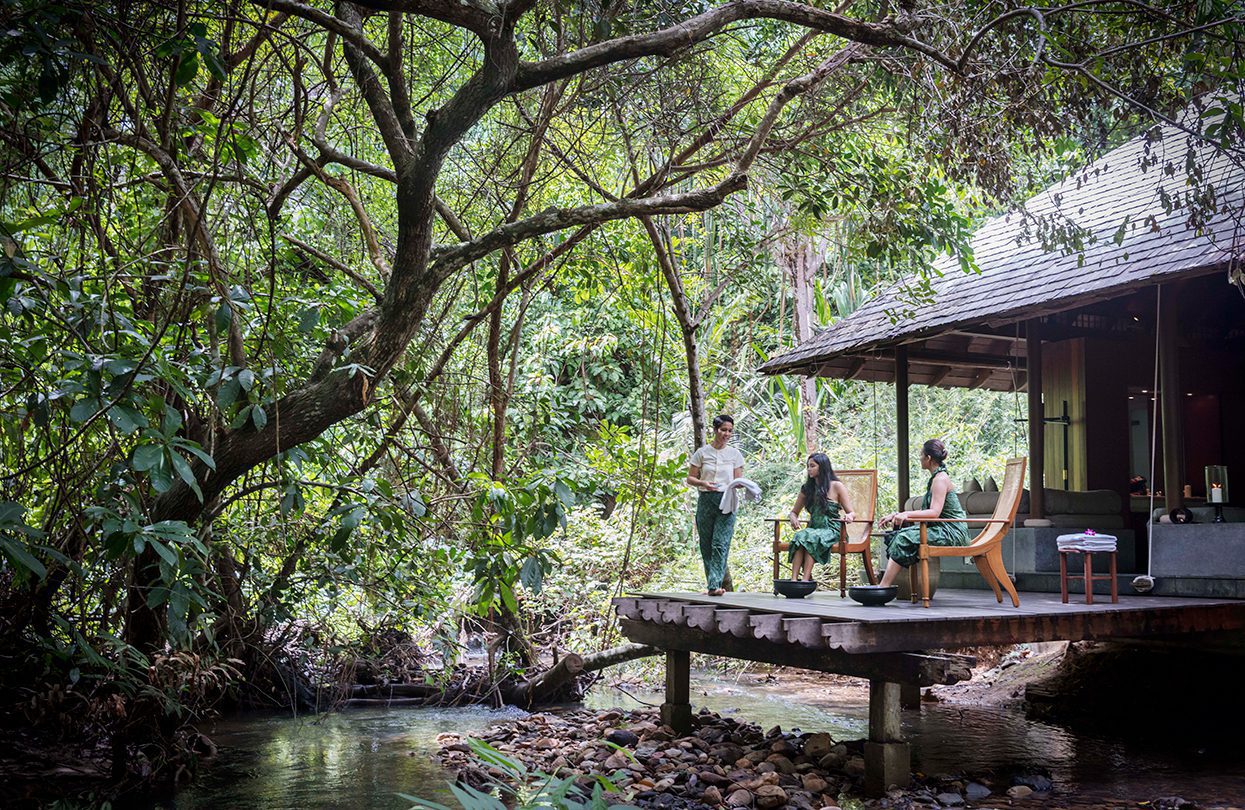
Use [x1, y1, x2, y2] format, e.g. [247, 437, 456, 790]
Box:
[614, 590, 1245, 796]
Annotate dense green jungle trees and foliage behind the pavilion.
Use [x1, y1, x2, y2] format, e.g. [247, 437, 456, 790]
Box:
[0, 0, 1245, 790]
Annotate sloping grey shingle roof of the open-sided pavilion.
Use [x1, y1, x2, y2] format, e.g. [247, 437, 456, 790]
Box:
[761, 113, 1245, 375]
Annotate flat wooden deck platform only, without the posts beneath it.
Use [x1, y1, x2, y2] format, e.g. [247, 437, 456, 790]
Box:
[615, 590, 1245, 656]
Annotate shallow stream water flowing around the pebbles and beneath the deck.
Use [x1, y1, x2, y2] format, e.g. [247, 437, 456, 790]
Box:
[173, 673, 1245, 810]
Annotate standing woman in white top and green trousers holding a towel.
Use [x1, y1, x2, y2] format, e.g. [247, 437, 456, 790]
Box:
[687, 413, 743, 596]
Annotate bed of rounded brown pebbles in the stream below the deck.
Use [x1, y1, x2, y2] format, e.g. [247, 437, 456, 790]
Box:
[425, 709, 1050, 810]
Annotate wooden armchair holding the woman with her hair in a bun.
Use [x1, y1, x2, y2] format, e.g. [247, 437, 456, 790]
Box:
[911, 458, 1028, 607]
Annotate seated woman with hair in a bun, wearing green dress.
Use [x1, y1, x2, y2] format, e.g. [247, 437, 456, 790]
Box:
[879, 439, 970, 585]
